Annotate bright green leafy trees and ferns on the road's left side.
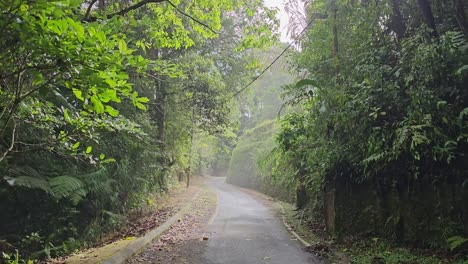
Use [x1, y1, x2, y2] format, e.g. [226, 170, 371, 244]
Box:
[0, 0, 277, 258]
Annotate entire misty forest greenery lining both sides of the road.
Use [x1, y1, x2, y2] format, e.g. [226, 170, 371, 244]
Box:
[0, 0, 468, 263]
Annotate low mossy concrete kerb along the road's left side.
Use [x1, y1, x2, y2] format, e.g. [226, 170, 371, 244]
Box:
[103, 189, 201, 264]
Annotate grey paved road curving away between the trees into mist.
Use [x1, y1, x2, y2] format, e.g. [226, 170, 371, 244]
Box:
[199, 178, 320, 264]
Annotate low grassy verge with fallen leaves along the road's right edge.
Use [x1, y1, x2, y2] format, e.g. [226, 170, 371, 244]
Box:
[274, 201, 468, 264]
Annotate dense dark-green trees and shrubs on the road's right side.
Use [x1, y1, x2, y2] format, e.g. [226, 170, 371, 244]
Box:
[266, 0, 468, 252]
